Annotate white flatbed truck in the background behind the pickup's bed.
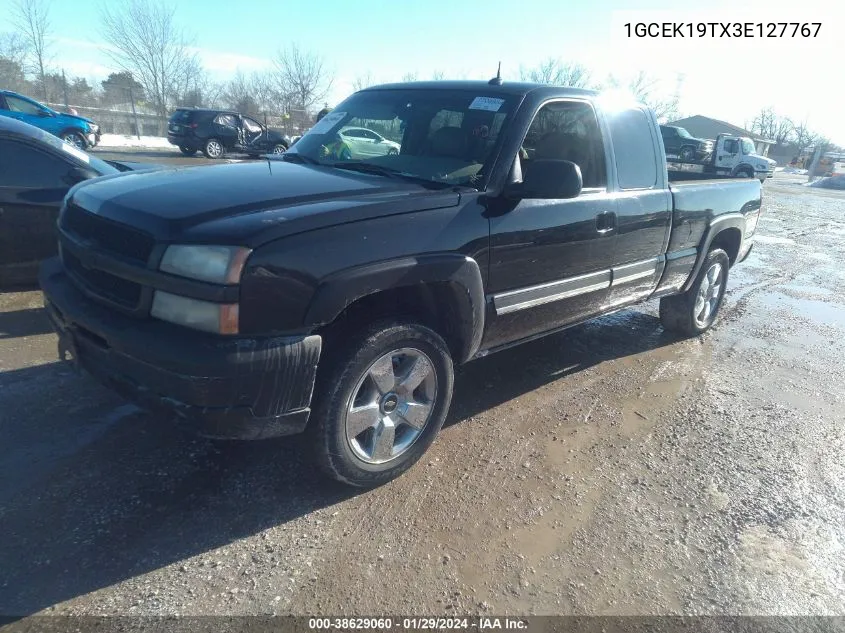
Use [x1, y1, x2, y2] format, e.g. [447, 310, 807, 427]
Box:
[666, 134, 777, 182]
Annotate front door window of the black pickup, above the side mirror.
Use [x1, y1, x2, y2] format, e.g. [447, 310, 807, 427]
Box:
[520, 101, 607, 188]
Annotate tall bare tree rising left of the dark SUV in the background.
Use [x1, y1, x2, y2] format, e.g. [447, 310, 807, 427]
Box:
[101, 0, 199, 128]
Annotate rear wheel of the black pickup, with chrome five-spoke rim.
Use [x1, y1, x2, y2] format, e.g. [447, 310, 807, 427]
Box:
[660, 248, 730, 336]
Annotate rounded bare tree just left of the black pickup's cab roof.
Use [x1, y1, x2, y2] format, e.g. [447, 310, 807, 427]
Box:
[274, 44, 333, 110]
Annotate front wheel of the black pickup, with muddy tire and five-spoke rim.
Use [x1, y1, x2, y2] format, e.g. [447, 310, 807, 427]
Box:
[311, 321, 454, 487]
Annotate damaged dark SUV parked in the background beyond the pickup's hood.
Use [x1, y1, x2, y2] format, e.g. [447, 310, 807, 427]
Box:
[167, 108, 290, 158]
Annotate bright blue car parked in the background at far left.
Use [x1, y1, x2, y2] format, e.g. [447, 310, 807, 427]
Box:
[0, 90, 100, 149]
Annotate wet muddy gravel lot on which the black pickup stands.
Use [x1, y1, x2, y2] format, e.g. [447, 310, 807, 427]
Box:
[0, 169, 845, 615]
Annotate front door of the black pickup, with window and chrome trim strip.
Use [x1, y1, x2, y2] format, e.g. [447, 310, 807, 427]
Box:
[483, 100, 616, 348]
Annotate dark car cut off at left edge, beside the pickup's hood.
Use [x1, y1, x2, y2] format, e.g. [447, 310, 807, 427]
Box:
[0, 117, 154, 287]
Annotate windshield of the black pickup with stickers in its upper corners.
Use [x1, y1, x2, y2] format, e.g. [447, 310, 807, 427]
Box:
[284, 89, 516, 187]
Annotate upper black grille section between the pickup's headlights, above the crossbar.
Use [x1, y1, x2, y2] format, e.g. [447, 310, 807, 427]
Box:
[62, 204, 155, 263]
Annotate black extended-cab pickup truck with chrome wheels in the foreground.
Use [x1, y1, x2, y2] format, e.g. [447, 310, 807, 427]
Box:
[40, 80, 761, 486]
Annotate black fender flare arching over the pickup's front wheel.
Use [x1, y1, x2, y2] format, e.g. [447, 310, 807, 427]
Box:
[305, 253, 485, 363]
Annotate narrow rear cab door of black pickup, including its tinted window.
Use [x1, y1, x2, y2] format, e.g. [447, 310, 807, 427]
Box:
[603, 105, 672, 309]
